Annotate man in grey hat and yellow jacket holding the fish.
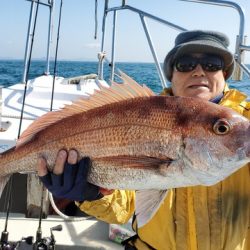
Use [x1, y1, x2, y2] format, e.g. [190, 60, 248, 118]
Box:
[38, 30, 250, 250]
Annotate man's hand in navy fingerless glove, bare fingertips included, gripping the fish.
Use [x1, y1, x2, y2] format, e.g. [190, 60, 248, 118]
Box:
[37, 150, 106, 201]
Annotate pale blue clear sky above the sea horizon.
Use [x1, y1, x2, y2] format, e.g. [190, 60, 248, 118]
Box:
[0, 0, 250, 63]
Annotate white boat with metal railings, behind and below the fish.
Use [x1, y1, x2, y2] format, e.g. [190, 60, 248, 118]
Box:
[0, 0, 250, 249]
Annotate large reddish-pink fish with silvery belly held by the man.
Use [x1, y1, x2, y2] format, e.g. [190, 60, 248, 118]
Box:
[0, 72, 250, 226]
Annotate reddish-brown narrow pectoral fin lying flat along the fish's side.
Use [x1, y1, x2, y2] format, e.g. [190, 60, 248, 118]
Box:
[95, 155, 173, 168]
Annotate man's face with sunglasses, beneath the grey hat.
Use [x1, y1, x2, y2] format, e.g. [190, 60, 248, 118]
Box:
[172, 54, 225, 100]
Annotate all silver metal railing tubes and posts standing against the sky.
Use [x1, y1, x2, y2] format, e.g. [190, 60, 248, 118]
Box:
[23, 0, 250, 88]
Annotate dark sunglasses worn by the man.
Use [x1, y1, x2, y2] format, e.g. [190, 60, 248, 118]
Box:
[174, 55, 224, 72]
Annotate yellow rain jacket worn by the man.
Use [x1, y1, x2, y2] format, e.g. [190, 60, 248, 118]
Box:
[78, 88, 250, 250]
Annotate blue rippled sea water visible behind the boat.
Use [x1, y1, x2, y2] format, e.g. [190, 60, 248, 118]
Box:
[0, 60, 250, 96]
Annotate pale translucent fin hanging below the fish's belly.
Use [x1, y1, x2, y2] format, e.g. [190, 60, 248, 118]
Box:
[135, 189, 168, 228]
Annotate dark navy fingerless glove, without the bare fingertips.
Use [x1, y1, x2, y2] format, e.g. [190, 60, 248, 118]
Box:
[39, 157, 103, 202]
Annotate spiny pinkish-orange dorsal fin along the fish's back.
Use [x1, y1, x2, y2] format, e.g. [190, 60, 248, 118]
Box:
[16, 72, 155, 147]
